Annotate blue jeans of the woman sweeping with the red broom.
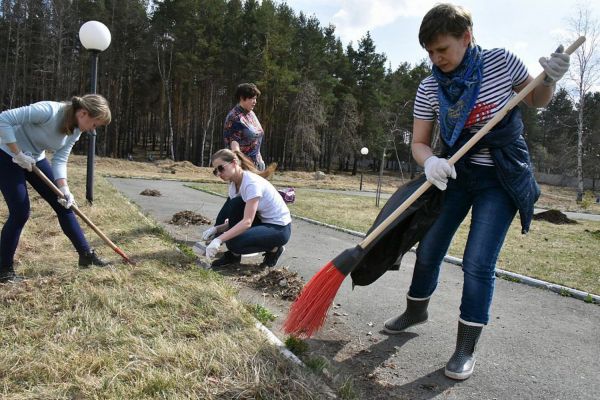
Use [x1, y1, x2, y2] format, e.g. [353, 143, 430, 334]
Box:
[408, 163, 517, 324]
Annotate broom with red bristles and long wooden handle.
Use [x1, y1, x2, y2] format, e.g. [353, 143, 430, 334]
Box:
[283, 36, 585, 337]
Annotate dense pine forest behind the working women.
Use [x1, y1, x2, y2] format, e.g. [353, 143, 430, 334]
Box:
[0, 0, 600, 195]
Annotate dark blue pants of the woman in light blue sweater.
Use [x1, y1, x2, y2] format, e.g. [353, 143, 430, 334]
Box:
[0, 150, 90, 270]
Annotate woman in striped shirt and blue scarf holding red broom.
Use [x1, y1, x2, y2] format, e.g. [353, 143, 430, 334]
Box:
[384, 4, 569, 380]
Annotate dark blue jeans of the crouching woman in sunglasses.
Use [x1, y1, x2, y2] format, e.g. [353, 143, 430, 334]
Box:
[217, 197, 292, 254]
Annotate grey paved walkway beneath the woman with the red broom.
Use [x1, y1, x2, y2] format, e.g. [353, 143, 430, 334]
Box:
[109, 178, 600, 400]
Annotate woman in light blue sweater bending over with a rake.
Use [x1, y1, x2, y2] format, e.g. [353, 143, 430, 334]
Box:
[0, 94, 111, 283]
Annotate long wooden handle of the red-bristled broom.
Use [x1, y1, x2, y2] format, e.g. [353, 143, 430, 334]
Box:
[358, 36, 585, 249]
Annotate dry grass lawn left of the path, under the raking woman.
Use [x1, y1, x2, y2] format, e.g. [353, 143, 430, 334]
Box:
[0, 161, 330, 399]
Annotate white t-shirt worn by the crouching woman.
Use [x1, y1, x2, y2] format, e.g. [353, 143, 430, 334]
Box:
[229, 171, 292, 226]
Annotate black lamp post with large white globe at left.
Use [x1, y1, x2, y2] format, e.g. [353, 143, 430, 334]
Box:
[79, 21, 111, 204]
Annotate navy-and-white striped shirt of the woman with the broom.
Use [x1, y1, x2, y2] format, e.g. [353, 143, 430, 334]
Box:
[413, 49, 529, 166]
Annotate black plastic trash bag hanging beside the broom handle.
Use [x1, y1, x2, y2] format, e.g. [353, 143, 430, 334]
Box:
[350, 174, 444, 286]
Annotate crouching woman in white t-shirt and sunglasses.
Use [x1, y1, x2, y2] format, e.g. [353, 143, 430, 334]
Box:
[202, 149, 292, 267]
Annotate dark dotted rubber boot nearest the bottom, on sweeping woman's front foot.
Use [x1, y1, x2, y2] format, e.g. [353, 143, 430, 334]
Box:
[444, 319, 483, 381]
